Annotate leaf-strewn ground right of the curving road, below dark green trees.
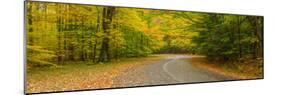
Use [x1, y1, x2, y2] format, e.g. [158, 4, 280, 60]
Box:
[190, 57, 263, 79]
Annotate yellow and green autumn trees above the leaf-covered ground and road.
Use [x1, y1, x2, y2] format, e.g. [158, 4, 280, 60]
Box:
[25, 2, 263, 69]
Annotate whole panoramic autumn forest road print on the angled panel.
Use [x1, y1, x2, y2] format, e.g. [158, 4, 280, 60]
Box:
[25, 1, 264, 93]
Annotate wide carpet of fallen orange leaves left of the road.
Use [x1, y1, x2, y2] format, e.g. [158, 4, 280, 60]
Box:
[27, 56, 165, 93]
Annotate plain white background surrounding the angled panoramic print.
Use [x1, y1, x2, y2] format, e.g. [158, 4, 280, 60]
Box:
[0, 0, 281, 95]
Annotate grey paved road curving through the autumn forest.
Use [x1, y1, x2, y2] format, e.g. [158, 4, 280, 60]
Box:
[113, 55, 230, 87]
